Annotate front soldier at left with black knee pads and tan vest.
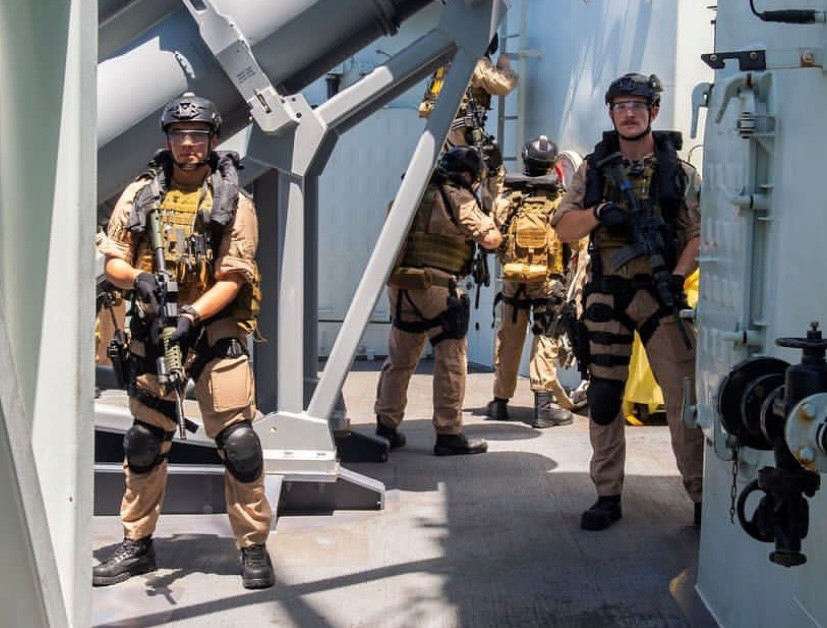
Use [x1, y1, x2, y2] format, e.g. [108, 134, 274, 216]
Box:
[93, 93, 274, 588]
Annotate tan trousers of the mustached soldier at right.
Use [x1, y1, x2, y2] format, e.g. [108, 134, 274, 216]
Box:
[585, 289, 704, 502]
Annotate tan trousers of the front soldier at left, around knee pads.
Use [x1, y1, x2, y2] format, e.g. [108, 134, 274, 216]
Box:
[121, 332, 272, 547]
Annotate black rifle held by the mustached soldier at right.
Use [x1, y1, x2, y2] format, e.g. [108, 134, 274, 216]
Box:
[597, 152, 692, 348]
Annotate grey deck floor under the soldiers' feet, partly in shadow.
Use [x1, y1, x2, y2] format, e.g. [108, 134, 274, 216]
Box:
[93, 362, 725, 627]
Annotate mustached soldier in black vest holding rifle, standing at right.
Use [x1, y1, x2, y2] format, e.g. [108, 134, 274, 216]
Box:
[552, 74, 703, 530]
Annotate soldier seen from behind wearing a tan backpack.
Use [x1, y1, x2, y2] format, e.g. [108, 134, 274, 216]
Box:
[488, 135, 574, 428]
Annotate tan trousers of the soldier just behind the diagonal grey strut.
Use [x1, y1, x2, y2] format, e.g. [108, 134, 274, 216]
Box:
[374, 286, 468, 434]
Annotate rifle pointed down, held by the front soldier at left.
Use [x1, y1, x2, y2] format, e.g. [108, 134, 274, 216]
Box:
[147, 208, 195, 440]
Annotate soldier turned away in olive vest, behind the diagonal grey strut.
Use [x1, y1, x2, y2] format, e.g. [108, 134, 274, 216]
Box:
[374, 147, 502, 456]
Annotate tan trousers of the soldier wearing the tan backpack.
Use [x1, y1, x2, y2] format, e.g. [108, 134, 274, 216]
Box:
[494, 279, 573, 409]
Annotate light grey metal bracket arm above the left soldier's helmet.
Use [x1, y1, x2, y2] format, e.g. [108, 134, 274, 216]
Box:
[181, 0, 299, 134]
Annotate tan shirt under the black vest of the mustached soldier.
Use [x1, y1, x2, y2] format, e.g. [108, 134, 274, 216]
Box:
[551, 155, 701, 277]
